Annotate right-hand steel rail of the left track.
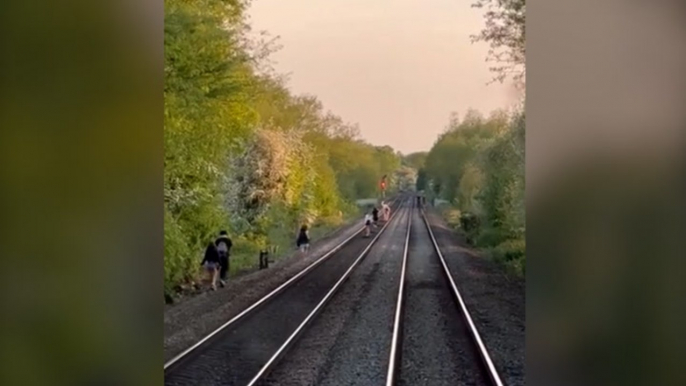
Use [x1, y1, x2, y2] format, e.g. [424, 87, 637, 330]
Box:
[248, 200, 407, 386]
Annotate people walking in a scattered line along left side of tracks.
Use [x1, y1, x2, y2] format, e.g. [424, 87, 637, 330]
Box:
[200, 201, 391, 291]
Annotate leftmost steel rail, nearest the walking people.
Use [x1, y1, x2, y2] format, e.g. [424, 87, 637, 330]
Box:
[164, 198, 402, 372]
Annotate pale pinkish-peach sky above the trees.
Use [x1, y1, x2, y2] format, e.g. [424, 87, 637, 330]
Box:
[249, 0, 515, 154]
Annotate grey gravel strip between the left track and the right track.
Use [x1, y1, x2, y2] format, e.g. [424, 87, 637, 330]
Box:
[263, 201, 408, 386]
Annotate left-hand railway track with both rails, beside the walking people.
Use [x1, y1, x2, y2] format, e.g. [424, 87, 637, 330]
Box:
[164, 198, 404, 386]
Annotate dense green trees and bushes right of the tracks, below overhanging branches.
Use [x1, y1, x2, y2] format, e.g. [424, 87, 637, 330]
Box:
[418, 111, 526, 274]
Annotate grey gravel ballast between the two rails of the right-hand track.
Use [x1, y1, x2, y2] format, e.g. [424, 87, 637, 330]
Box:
[397, 211, 488, 386]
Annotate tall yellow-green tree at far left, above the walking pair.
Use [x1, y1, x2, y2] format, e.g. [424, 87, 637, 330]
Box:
[164, 0, 256, 288]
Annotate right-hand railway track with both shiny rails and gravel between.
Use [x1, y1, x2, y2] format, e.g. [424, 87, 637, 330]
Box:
[386, 204, 503, 386]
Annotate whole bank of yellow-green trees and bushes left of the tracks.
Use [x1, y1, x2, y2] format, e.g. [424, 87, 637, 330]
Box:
[164, 0, 411, 293]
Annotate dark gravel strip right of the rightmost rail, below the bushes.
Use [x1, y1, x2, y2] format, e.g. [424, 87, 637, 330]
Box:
[426, 210, 526, 386]
